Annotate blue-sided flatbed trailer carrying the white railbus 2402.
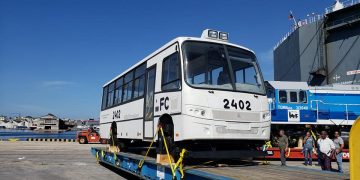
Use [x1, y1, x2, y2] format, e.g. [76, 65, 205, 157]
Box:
[91, 147, 349, 180]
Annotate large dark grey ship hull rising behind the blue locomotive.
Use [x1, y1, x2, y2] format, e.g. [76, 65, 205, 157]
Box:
[274, 0, 360, 86]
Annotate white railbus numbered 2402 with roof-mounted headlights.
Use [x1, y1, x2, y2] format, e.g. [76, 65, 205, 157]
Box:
[100, 29, 270, 152]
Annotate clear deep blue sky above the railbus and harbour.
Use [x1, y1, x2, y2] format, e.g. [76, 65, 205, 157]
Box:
[0, 0, 334, 119]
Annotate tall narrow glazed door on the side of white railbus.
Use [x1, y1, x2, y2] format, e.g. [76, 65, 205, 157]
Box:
[143, 65, 156, 139]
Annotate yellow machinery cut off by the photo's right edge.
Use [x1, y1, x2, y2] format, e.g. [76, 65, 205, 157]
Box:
[349, 116, 360, 179]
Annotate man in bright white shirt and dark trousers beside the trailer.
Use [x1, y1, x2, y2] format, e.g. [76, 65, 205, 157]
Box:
[318, 131, 335, 171]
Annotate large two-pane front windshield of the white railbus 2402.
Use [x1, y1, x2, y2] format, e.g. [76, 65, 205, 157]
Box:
[183, 41, 265, 94]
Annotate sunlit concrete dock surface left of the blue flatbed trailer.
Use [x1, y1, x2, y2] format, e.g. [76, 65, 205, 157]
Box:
[0, 141, 126, 180]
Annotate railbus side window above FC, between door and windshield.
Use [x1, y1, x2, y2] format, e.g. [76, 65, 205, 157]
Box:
[161, 52, 180, 90]
